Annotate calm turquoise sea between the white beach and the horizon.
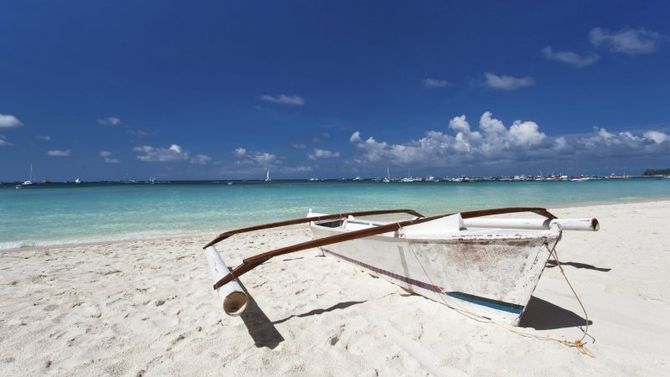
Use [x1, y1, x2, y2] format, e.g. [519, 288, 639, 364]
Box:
[0, 179, 670, 249]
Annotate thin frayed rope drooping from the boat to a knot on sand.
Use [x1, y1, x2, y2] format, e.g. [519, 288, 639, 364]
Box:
[398, 224, 595, 357]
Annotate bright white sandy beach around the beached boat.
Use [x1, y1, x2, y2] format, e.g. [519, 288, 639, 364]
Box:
[0, 201, 670, 376]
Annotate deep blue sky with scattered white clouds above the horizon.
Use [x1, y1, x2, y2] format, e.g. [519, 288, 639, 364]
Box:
[0, 0, 670, 181]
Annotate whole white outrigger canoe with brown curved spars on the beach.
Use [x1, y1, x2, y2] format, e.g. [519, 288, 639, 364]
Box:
[204, 207, 599, 325]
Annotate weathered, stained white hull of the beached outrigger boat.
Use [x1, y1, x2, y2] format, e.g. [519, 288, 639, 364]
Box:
[311, 226, 559, 325]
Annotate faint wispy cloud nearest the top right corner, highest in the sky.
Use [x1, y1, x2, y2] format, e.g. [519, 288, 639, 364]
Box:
[589, 27, 666, 55]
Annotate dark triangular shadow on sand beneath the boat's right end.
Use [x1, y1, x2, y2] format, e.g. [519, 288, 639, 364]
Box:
[519, 296, 593, 330]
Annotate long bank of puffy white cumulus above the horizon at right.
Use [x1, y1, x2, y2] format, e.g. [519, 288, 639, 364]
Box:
[352, 111, 670, 168]
